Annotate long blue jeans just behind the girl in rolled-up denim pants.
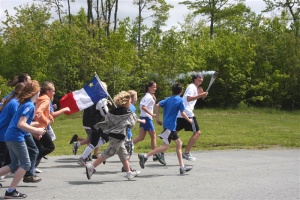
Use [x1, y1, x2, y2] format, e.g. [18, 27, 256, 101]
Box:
[25, 135, 39, 176]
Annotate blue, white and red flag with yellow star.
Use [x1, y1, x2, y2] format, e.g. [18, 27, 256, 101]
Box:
[59, 76, 108, 115]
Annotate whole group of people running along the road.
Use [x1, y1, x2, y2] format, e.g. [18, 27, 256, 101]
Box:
[0, 73, 208, 199]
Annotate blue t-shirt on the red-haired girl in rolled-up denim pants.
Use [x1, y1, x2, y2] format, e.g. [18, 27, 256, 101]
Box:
[5, 100, 34, 142]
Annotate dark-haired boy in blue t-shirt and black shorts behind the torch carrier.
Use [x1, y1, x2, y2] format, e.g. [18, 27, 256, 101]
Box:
[138, 83, 192, 174]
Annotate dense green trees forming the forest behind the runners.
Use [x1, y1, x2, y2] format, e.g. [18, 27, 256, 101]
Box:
[0, 0, 300, 110]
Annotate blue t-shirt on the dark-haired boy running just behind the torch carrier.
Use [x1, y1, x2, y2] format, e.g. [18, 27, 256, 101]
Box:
[158, 95, 185, 131]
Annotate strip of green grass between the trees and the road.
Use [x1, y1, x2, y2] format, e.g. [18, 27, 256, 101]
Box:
[51, 108, 300, 155]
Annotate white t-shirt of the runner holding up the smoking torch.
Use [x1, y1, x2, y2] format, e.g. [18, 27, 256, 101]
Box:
[177, 83, 198, 118]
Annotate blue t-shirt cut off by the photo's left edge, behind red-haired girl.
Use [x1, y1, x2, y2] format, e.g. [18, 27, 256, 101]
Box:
[0, 98, 19, 142]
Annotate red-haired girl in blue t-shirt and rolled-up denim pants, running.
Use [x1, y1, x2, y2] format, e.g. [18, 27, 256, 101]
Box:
[0, 81, 45, 199]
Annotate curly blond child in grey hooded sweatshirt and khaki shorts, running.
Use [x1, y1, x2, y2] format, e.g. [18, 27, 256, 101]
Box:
[86, 91, 140, 180]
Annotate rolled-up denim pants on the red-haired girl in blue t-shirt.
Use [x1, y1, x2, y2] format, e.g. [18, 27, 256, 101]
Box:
[6, 141, 31, 173]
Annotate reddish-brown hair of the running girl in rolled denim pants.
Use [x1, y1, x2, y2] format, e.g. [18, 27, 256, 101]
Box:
[18, 80, 41, 104]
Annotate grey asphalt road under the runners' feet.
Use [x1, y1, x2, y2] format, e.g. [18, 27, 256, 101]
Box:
[0, 149, 300, 200]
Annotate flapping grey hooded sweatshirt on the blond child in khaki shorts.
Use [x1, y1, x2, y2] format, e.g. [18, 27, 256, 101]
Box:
[94, 107, 137, 139]
